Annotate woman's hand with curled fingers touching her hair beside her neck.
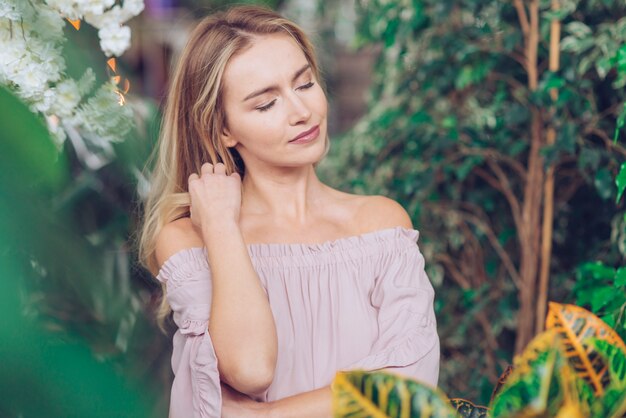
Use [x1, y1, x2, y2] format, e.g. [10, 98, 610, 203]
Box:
[188, 163, 241, 231]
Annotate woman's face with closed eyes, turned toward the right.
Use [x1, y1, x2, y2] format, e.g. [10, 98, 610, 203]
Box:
[222, 34, 327, 168]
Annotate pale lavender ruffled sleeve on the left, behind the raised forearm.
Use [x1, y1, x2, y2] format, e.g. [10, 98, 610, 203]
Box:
[157, 248, 222, 418]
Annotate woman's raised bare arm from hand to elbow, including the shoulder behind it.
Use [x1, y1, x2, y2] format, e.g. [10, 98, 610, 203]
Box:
[156, 164, 278, 396]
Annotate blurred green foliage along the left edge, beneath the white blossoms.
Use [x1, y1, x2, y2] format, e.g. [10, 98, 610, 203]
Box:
[0, 89, 162, 417]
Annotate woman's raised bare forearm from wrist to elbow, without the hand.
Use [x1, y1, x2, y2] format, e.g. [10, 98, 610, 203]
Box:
[202, 222, 277, 395]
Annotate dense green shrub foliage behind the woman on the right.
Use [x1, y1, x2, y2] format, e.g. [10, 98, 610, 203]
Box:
[320, 0, 626, 404]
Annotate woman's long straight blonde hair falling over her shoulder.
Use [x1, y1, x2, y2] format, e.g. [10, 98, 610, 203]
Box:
[139, 6, 321, 324]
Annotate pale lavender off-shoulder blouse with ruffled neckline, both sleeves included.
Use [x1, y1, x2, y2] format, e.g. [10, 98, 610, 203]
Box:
[157, 227, 439, 418]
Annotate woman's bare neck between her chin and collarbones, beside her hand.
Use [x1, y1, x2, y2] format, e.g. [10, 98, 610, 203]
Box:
[242, 165, 326, 225]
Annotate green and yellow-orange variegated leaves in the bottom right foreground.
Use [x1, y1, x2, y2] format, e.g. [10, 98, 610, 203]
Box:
[332, 303, 626, 418]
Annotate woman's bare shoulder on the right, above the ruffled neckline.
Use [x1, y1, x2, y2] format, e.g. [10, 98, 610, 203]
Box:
[355, 196, 413, 232]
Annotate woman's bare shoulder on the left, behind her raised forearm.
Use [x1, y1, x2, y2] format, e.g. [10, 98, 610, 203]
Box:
[156, 218, 204, 268]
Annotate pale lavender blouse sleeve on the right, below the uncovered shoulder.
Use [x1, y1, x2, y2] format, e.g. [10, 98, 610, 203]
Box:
[344, 228, 439, 386]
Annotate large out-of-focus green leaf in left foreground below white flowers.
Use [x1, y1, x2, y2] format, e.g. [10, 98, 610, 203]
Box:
[0, 89, 152, 417]
